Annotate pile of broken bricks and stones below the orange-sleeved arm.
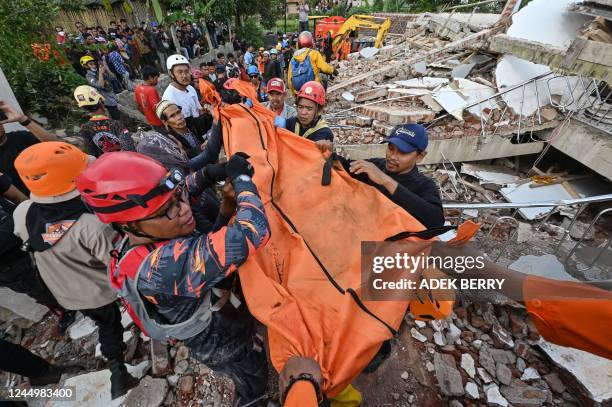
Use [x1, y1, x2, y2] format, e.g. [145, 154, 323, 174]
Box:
[406, 296, 612, 407]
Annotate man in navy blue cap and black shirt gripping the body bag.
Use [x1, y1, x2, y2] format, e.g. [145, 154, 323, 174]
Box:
[319, 123, 444, 228]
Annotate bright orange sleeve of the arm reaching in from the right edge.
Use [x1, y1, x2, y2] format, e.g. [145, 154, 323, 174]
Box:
[523, 276, 612, 359]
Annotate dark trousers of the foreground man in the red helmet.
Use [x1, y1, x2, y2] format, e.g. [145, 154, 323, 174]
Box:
[184, 296, 268, 405]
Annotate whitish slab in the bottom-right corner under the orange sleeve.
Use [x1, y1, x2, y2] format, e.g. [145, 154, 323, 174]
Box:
[538, 340, 612, 402]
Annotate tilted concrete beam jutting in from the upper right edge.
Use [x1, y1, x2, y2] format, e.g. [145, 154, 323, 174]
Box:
[489, 34, 612, 81]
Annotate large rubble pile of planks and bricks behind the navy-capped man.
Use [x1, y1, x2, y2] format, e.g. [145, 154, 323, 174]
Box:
[326, 14, 564, 144]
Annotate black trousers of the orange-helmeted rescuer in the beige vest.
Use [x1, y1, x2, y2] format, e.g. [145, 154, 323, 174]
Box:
[80, 302, 126, 360]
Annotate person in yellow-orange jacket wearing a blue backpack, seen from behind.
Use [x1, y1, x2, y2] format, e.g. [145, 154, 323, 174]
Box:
[287, 31, 338, 95]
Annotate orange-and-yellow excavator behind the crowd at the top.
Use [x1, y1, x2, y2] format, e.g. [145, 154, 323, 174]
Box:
[309, 14, 391, 60]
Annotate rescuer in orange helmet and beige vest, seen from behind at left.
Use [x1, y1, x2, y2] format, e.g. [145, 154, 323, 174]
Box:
[13, 141, 138, 399]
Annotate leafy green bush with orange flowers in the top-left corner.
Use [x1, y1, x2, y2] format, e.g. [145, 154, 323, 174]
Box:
[0, 0, 85, 123]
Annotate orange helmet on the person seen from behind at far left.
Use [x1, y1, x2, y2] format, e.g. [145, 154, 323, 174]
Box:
[15, 141, 88, 197]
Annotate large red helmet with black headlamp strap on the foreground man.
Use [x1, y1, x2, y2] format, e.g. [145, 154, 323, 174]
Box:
[76, 151, 177, 223]
